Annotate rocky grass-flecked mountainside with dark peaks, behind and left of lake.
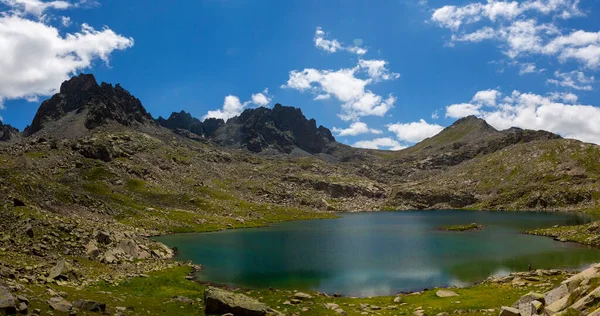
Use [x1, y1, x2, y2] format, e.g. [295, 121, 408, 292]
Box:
[0, 75, 600, 314]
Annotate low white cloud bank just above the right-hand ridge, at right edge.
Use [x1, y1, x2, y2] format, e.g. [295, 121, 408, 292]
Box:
[446, 91, 600, 144]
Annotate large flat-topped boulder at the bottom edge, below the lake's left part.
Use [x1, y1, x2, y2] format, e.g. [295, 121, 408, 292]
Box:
[204, 287, 268, 316]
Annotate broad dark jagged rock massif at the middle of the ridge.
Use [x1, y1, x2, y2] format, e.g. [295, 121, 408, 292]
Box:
[213, 104, 335, 154]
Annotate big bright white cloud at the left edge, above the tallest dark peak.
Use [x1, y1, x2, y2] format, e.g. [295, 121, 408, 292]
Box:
[0, 13, 133, 107]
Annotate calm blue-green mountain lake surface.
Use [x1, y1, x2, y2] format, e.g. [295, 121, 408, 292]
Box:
[157, 211, 600, 296]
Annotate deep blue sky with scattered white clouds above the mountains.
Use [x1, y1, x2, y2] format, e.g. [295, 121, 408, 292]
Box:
[0, 0, 600, 150]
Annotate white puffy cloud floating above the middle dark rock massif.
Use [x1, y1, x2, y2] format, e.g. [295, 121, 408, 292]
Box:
[282, 59, 399, 121]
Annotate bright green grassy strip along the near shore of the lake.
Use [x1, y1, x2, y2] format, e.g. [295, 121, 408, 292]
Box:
[23, 267, 561, 315]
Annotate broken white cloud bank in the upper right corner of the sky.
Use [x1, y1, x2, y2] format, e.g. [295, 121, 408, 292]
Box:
[431, 0, 600, 68]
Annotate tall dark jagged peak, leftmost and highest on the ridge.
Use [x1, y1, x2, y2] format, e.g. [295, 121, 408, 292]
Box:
[25, 74, 154, 136]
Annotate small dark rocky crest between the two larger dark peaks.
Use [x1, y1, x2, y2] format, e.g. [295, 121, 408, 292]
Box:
[156, 111, 225, 137]
